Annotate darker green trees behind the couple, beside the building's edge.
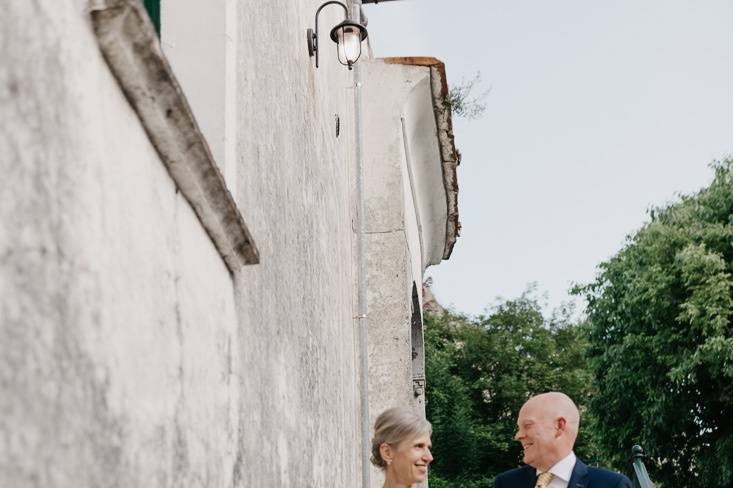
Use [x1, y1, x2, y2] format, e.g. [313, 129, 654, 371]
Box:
[425, 294, 596, 488]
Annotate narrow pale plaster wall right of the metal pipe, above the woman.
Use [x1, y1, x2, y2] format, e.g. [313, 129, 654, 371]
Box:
[363, 60, 432, 488]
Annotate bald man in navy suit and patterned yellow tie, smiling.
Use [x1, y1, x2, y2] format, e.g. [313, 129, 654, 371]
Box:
[494, 392, 631, 488]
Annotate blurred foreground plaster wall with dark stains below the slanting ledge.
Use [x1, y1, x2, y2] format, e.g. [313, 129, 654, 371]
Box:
[0, 0, 242, 488]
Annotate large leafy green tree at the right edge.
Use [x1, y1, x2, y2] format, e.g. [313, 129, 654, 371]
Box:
[577, 160, 733, 488]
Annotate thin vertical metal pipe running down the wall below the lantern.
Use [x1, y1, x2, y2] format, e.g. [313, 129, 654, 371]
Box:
[352, 0, 371, 488]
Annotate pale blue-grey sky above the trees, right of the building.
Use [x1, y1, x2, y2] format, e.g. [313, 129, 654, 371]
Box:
[364, 0, 733, 314]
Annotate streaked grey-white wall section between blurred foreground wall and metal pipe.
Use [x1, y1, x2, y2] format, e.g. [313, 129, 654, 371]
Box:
[232, 0, 361, 487]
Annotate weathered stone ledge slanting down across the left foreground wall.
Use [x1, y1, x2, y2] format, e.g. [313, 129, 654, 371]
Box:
[90, 0, 259, 273]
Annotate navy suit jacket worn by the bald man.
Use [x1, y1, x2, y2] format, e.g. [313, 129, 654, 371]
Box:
[494, 460, 631, 488]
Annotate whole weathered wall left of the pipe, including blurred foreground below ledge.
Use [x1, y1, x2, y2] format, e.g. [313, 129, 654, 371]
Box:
[0, 0, 360, 488]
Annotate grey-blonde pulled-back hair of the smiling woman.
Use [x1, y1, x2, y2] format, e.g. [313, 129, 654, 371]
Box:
[371, 407, 433, 469]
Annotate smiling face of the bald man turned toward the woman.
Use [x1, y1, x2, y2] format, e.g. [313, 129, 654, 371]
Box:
[514, 400, 559, 471]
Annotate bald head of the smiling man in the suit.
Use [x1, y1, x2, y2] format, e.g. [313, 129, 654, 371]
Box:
[515, 392, 580, 471]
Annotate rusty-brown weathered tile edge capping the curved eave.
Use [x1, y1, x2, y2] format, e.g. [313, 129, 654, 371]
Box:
[384, 56, 461, 259]
